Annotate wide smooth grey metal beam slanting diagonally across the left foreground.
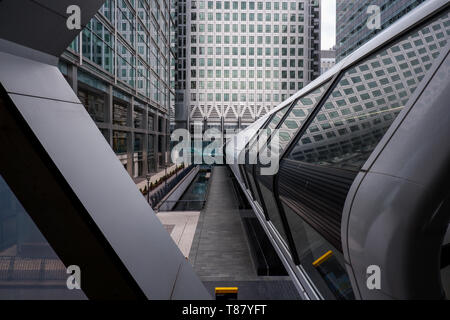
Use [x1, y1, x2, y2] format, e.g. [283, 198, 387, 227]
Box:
[0, 55, 210, 299]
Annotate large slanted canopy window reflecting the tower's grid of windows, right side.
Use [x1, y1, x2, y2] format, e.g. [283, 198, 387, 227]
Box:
[289, 13, 450, 170]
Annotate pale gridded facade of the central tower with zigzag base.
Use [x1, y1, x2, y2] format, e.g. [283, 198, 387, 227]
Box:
[176, 0, 320, 131]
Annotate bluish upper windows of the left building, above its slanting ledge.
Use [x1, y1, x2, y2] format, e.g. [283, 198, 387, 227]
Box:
[74, 0, 169, 108]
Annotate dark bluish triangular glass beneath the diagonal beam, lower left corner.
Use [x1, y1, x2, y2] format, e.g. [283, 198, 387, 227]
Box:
[0, 175, 86, 299]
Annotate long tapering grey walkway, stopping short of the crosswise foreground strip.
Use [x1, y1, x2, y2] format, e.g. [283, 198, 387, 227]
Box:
[189, 166, 258, 281]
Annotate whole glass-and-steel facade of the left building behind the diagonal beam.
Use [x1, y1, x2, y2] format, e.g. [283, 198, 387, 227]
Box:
[59, 0, 175, 177]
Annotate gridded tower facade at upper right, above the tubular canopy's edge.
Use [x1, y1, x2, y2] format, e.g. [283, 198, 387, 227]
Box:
[336, 0, 432, 61]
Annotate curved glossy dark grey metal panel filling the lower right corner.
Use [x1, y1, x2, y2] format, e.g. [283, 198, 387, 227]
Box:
[348, 173, 449, 300]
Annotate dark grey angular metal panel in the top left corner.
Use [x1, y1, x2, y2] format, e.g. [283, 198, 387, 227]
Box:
[0, 0, 104, 57]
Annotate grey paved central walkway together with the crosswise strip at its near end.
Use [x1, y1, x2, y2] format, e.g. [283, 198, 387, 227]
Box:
[189, 166, 299, 300]
